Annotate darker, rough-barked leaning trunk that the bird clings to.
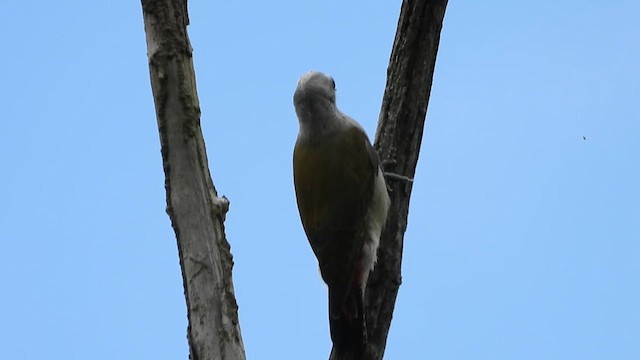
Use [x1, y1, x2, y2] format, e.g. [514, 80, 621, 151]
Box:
[364, 0, 447, 360]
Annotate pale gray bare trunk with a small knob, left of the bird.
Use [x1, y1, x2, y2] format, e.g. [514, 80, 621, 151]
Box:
[142, 0, 245, 360]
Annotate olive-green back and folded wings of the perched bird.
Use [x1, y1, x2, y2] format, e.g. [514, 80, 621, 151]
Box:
[293, 126, 377, 296]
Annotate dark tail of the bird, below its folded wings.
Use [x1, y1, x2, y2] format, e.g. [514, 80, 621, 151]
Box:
[329, 286, 367, 360]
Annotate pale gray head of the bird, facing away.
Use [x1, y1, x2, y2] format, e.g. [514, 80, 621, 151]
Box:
[293, 71, 337, 125]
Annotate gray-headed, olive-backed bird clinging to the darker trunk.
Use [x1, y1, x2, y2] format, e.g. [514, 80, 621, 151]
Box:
[293, 71, 391, 359]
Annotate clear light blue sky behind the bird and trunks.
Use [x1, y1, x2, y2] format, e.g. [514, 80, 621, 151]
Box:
[0, 0, 640, 360]
